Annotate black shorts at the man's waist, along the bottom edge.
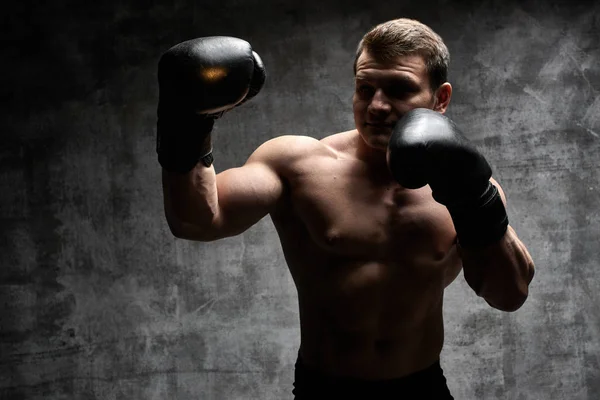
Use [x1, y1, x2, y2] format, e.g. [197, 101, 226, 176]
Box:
[292, 357, 454, 400]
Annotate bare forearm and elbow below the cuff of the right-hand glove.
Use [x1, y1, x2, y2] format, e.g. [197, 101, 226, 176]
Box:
[459, 226, 534, 311]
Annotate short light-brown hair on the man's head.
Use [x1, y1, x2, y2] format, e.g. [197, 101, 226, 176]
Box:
[354, 18, 450, 90]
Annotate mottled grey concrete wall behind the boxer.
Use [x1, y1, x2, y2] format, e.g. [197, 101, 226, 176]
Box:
[0, 0, 600, 400]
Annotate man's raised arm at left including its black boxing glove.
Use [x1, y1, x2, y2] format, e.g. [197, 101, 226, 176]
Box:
[157, 37, 282, 240]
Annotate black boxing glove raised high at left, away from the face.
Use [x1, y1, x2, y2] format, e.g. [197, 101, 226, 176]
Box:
[156, 36, 266, 174]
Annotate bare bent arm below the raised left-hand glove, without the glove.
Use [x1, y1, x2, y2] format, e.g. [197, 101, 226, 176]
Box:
[163, 138, 284, 241]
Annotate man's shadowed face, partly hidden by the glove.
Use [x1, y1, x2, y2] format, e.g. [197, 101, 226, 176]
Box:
[352, 50, 436, 151]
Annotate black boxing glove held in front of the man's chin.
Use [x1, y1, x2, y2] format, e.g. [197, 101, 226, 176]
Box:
[387, 108, 508, 247]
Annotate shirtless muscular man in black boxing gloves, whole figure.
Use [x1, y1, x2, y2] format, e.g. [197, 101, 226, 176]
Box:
[157, 19, 534, 399]
